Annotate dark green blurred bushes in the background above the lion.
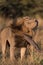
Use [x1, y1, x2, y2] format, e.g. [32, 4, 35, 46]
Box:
[0, 0, 43, 17]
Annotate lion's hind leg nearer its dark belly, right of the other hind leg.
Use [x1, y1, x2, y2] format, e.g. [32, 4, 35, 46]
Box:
[8, 37, 15, 61]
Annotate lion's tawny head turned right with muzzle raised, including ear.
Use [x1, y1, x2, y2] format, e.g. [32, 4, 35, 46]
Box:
[16, 16, 38, 36]
